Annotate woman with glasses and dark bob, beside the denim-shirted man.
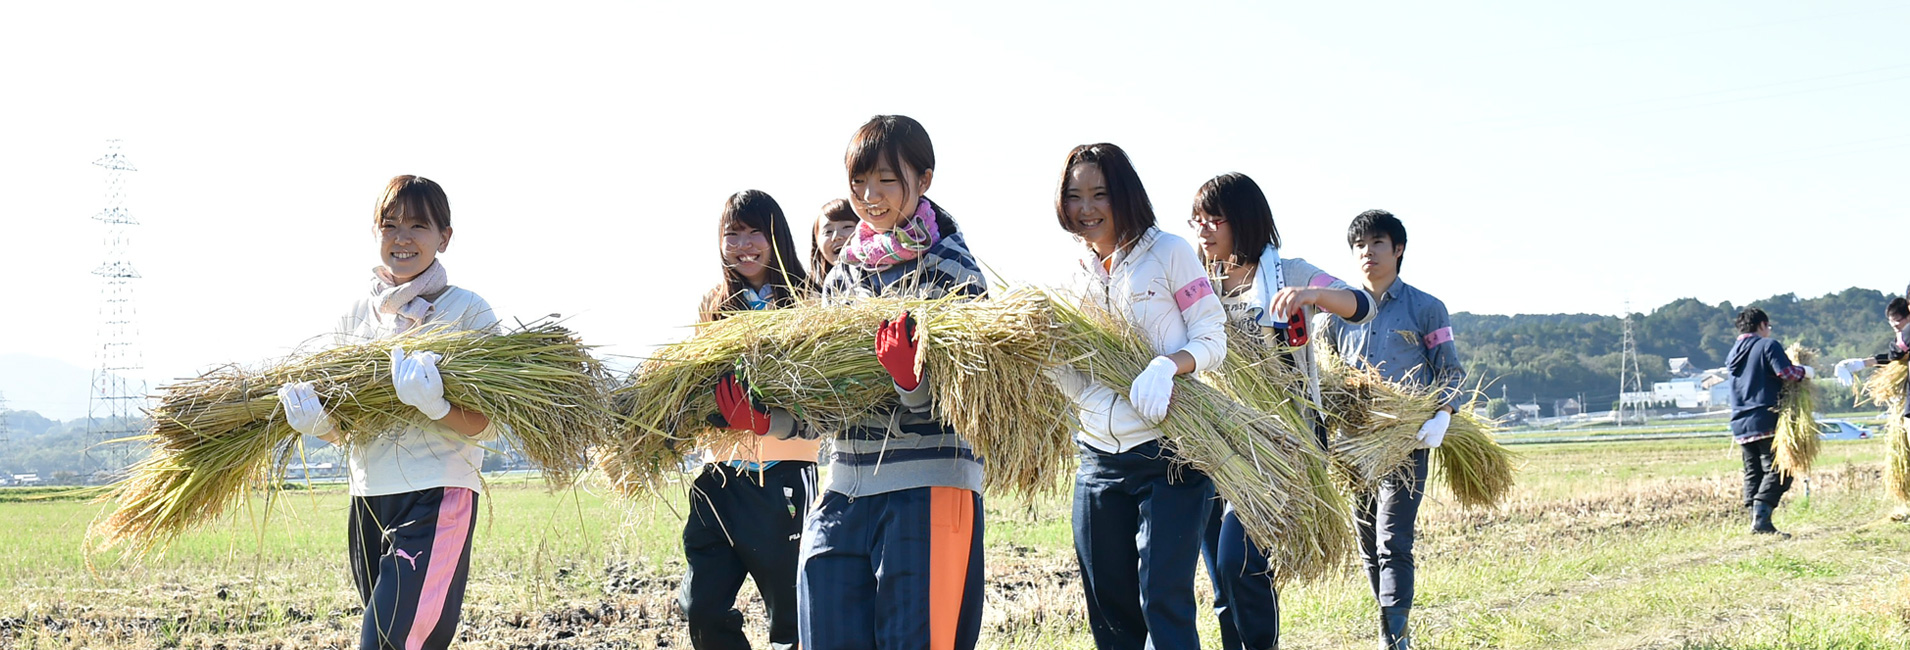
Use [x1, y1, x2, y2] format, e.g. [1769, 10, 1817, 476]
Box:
[1188, 174, 1373, 650]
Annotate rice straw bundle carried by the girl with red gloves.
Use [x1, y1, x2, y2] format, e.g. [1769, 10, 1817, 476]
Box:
[600, 289, 1073, 495]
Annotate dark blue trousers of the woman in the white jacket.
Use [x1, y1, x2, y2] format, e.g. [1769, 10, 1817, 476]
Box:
[1073, 442, 1213, 650]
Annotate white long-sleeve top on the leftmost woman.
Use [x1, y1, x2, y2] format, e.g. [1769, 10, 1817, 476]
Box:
[336, 287, 502, 497]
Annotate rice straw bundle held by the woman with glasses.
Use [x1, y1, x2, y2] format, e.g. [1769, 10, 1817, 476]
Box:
[1201, 323, 1354, 577]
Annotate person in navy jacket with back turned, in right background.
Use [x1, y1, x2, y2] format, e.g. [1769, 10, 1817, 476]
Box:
[1725, 308, 1815, 537]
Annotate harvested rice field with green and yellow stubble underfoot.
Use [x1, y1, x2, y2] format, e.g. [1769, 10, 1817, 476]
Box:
[0, 438, 1910, 650]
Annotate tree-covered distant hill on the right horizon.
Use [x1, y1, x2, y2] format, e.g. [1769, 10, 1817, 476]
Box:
[1452, 287, 1891, 413]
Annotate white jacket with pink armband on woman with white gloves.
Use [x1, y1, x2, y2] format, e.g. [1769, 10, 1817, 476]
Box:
[1052, 228, 1226, 453]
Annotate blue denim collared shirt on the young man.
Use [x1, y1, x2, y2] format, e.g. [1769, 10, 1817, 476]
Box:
[1324, 277, 1465, 405]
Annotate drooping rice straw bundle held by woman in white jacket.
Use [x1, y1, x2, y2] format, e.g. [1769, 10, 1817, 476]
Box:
[1054, 300, 1352, 581]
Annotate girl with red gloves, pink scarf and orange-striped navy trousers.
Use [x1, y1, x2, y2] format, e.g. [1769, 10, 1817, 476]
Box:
[732, 115, 987, 650]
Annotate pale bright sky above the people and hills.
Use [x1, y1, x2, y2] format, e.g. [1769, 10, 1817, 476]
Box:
[0, 2, 1910, 417]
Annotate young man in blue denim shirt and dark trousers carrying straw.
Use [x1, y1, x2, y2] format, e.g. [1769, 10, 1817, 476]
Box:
[1322, 210, 1465, 650]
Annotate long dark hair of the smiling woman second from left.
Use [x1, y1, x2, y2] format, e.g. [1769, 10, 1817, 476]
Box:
[703, 189, 814, 321]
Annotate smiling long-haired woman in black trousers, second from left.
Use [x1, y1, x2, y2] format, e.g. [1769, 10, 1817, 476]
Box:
[682, 189, 821, 650]
